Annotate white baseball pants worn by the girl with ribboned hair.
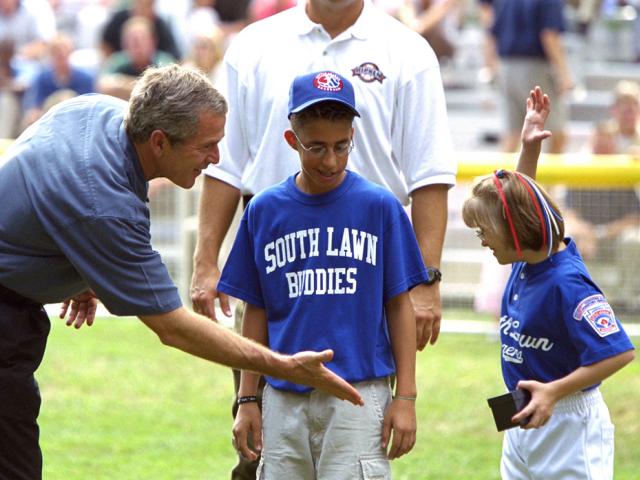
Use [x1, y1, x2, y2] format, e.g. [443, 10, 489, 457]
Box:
[500, 389, 614, 480]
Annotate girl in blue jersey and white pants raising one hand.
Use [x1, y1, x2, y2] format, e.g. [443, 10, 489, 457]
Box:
[462, 87, 635, 480]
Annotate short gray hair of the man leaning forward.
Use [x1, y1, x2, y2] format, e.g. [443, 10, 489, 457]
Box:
[124, 64, 227, 143]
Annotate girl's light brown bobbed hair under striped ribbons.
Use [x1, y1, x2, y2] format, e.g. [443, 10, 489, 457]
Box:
[462, 170, 564, 255]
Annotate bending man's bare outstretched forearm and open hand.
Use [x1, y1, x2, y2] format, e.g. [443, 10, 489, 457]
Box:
[140, 307, 363, 405]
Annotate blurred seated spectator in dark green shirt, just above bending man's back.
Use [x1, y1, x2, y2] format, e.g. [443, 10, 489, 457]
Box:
[97, 17, 175, 100]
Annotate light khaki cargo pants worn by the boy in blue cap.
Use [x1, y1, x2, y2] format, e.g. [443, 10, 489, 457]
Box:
[256, 378, 391, 480]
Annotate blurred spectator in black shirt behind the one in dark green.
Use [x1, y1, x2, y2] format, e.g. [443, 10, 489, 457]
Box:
[102, 0, 181, 58]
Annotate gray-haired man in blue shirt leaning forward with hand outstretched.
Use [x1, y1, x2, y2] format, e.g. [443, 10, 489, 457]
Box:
[0, 65, 362, 479]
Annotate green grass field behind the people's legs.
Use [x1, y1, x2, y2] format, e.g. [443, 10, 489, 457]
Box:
[37, 317, 640, 480]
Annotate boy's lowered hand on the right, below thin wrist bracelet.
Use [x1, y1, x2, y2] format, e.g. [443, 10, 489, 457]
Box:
[382, 399, 417, 460]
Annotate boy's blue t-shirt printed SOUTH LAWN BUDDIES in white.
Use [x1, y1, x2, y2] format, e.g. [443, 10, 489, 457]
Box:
[218, 172, 427, 392]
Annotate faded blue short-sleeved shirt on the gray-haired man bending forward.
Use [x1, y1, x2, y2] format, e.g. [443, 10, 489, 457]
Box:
[0, 94, 181, 315]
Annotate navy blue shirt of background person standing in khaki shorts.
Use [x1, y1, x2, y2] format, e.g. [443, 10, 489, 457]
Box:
[481, 0, 565, 58]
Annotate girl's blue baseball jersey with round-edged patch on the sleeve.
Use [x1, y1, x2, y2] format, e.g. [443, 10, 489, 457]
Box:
[500, 239, 634, 390]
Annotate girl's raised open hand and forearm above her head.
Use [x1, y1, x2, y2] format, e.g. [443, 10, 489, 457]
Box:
[516, 86, 551, 179]
